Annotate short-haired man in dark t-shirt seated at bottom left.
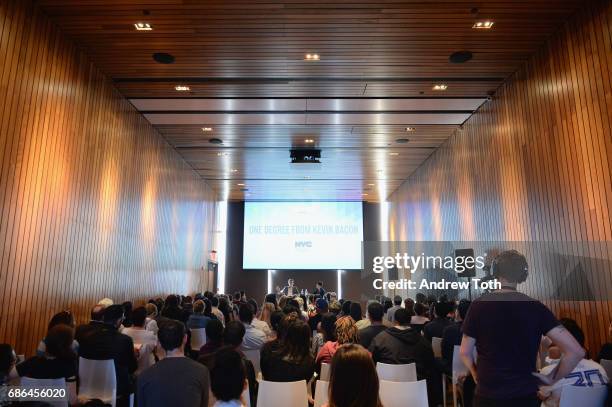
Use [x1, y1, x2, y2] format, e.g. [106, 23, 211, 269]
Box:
[137, 319, 210, 407]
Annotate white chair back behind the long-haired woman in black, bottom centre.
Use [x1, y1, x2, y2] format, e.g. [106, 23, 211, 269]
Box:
[257, 380, 308, 407]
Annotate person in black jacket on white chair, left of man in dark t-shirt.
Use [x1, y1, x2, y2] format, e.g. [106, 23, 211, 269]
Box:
[75, 305, 138, 404]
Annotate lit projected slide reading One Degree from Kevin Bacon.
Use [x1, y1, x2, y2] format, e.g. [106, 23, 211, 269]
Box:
[242, 202, 363, 270]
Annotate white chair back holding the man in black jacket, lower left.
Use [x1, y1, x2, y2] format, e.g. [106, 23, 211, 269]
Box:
[79, 357, 117, 407]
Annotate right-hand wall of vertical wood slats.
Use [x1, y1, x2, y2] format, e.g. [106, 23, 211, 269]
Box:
[390, 0, 612, 351]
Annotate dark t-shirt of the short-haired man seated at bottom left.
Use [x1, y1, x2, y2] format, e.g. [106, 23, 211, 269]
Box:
[136, 357, 210, 407]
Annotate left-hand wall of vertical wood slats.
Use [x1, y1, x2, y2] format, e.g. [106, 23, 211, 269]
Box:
[0, 0, 215, 354]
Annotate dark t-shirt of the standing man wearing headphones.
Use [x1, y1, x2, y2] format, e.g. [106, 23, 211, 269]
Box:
[463, 291, 559, 400]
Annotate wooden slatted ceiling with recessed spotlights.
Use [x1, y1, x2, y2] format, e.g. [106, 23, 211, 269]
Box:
[38, 0, 581, 201]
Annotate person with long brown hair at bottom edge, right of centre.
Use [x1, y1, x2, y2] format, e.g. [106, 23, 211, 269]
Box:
[325, 344, 382, 407]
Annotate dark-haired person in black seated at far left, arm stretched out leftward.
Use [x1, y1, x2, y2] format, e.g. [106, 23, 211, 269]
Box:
[10, 324, 78, 405]
